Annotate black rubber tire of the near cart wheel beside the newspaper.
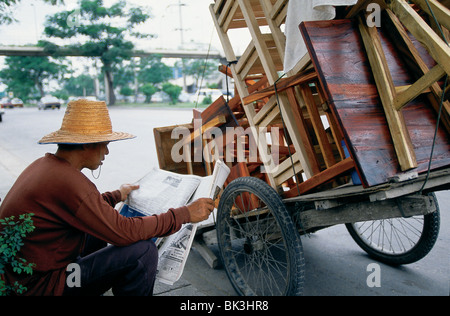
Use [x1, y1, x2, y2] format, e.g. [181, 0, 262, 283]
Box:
[216, 177, 305, 296]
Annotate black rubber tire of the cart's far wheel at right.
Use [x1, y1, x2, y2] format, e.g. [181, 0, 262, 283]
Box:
[346, 194, 440, 266]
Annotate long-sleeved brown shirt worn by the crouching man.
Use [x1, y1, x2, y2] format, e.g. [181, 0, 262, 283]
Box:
[0, 154, 190, 295]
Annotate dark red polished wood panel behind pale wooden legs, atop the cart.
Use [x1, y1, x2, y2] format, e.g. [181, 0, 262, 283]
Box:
[300, 20, 450, 186]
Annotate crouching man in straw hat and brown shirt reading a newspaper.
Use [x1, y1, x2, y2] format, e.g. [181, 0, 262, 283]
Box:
[0, 100, 214, 296]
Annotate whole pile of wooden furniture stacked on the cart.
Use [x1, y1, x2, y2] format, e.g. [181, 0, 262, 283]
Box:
[157, 0, 450, 198]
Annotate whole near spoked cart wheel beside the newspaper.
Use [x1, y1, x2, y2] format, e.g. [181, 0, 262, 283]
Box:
[216, 177, 305, 296]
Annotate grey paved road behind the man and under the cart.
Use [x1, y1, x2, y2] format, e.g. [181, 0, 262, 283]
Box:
[0, 108, 450, 296]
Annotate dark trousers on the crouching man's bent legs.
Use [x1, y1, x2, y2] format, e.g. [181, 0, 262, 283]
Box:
[64, 236, 158, 296]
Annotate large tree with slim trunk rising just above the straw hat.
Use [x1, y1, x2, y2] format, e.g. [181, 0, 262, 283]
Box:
[44, 0, 151, 105]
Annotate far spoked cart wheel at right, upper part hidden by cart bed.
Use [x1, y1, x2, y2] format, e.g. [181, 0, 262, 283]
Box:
[346, 194, 440, 265]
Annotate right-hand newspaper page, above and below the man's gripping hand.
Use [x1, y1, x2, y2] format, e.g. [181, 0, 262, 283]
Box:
[156, 160, 230, 285]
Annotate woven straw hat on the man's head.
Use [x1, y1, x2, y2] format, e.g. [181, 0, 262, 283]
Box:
[39, 99, 135, 144]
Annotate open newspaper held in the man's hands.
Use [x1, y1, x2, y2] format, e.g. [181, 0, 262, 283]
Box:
[126, 160, 230, 285]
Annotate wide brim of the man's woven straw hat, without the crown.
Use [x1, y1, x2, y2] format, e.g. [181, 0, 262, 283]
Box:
[38, 130, 136, 145]
